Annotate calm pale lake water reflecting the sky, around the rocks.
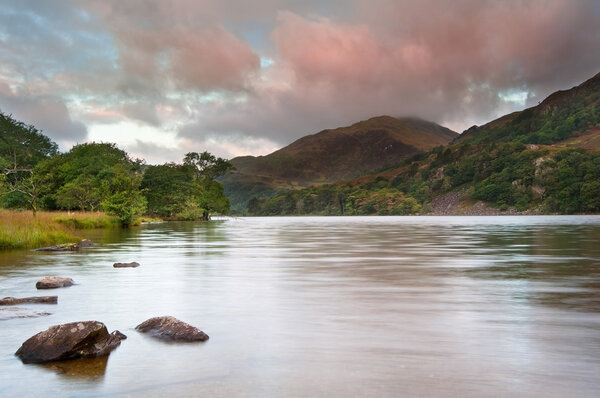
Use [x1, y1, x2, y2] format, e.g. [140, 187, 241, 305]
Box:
[0, 216, 600, 397]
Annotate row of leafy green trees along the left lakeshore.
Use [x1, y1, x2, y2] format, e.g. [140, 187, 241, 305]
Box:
[0, 112, 233, 226]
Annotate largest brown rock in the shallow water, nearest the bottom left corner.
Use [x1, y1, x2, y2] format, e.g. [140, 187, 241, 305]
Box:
[15, 321, 126, 363]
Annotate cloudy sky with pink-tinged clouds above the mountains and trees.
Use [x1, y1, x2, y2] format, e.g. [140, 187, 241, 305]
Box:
[0, 0, 600, 164]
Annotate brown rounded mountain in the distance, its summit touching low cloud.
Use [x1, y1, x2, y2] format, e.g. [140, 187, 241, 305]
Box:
[220, 116, 458, 210]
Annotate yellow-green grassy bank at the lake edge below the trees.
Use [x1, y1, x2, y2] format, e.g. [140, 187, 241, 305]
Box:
[0, 209, 118, 250]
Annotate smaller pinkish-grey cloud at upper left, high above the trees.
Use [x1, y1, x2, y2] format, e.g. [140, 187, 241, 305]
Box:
[88, 0, 260, 96]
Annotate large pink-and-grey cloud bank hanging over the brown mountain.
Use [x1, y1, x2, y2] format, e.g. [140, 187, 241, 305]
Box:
[180, 0, 600, 145]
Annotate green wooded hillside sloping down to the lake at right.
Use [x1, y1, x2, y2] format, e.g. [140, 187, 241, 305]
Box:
[249, 74, 600, 215]
